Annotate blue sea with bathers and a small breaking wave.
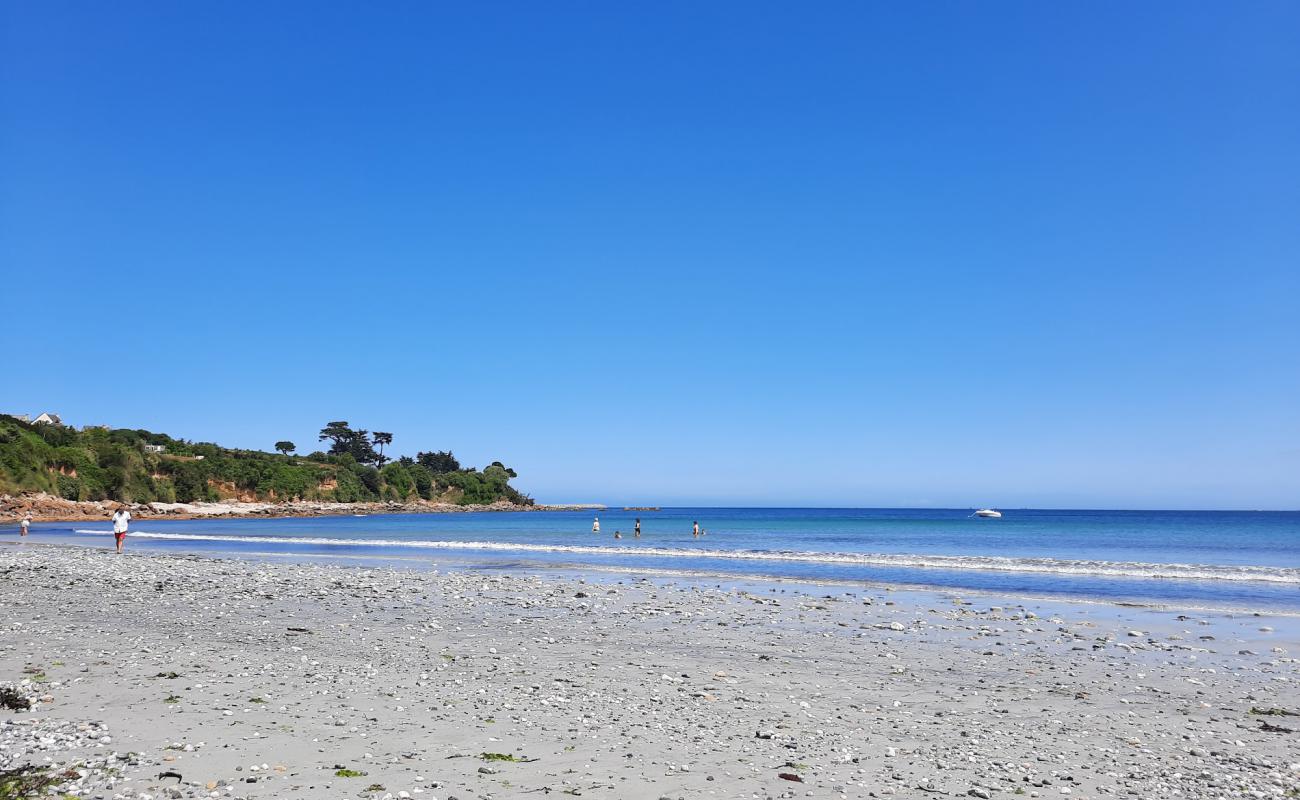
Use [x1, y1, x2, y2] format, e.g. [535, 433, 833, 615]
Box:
[17, 509, 1300, 613]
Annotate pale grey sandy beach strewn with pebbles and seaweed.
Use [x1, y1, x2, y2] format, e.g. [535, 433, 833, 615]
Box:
[0, 544, 1300, 800]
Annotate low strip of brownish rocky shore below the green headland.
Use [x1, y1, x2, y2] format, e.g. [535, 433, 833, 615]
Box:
[0, 492, 605, 522]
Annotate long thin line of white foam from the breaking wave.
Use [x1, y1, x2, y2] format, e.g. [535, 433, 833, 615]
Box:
[68, 529, 1300, 585]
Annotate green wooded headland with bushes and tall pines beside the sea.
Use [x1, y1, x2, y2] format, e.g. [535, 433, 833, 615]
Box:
[0, 415, 533, 505]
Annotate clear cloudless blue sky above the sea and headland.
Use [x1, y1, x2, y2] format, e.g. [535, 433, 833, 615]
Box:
[0, 0, 1300, 509]
